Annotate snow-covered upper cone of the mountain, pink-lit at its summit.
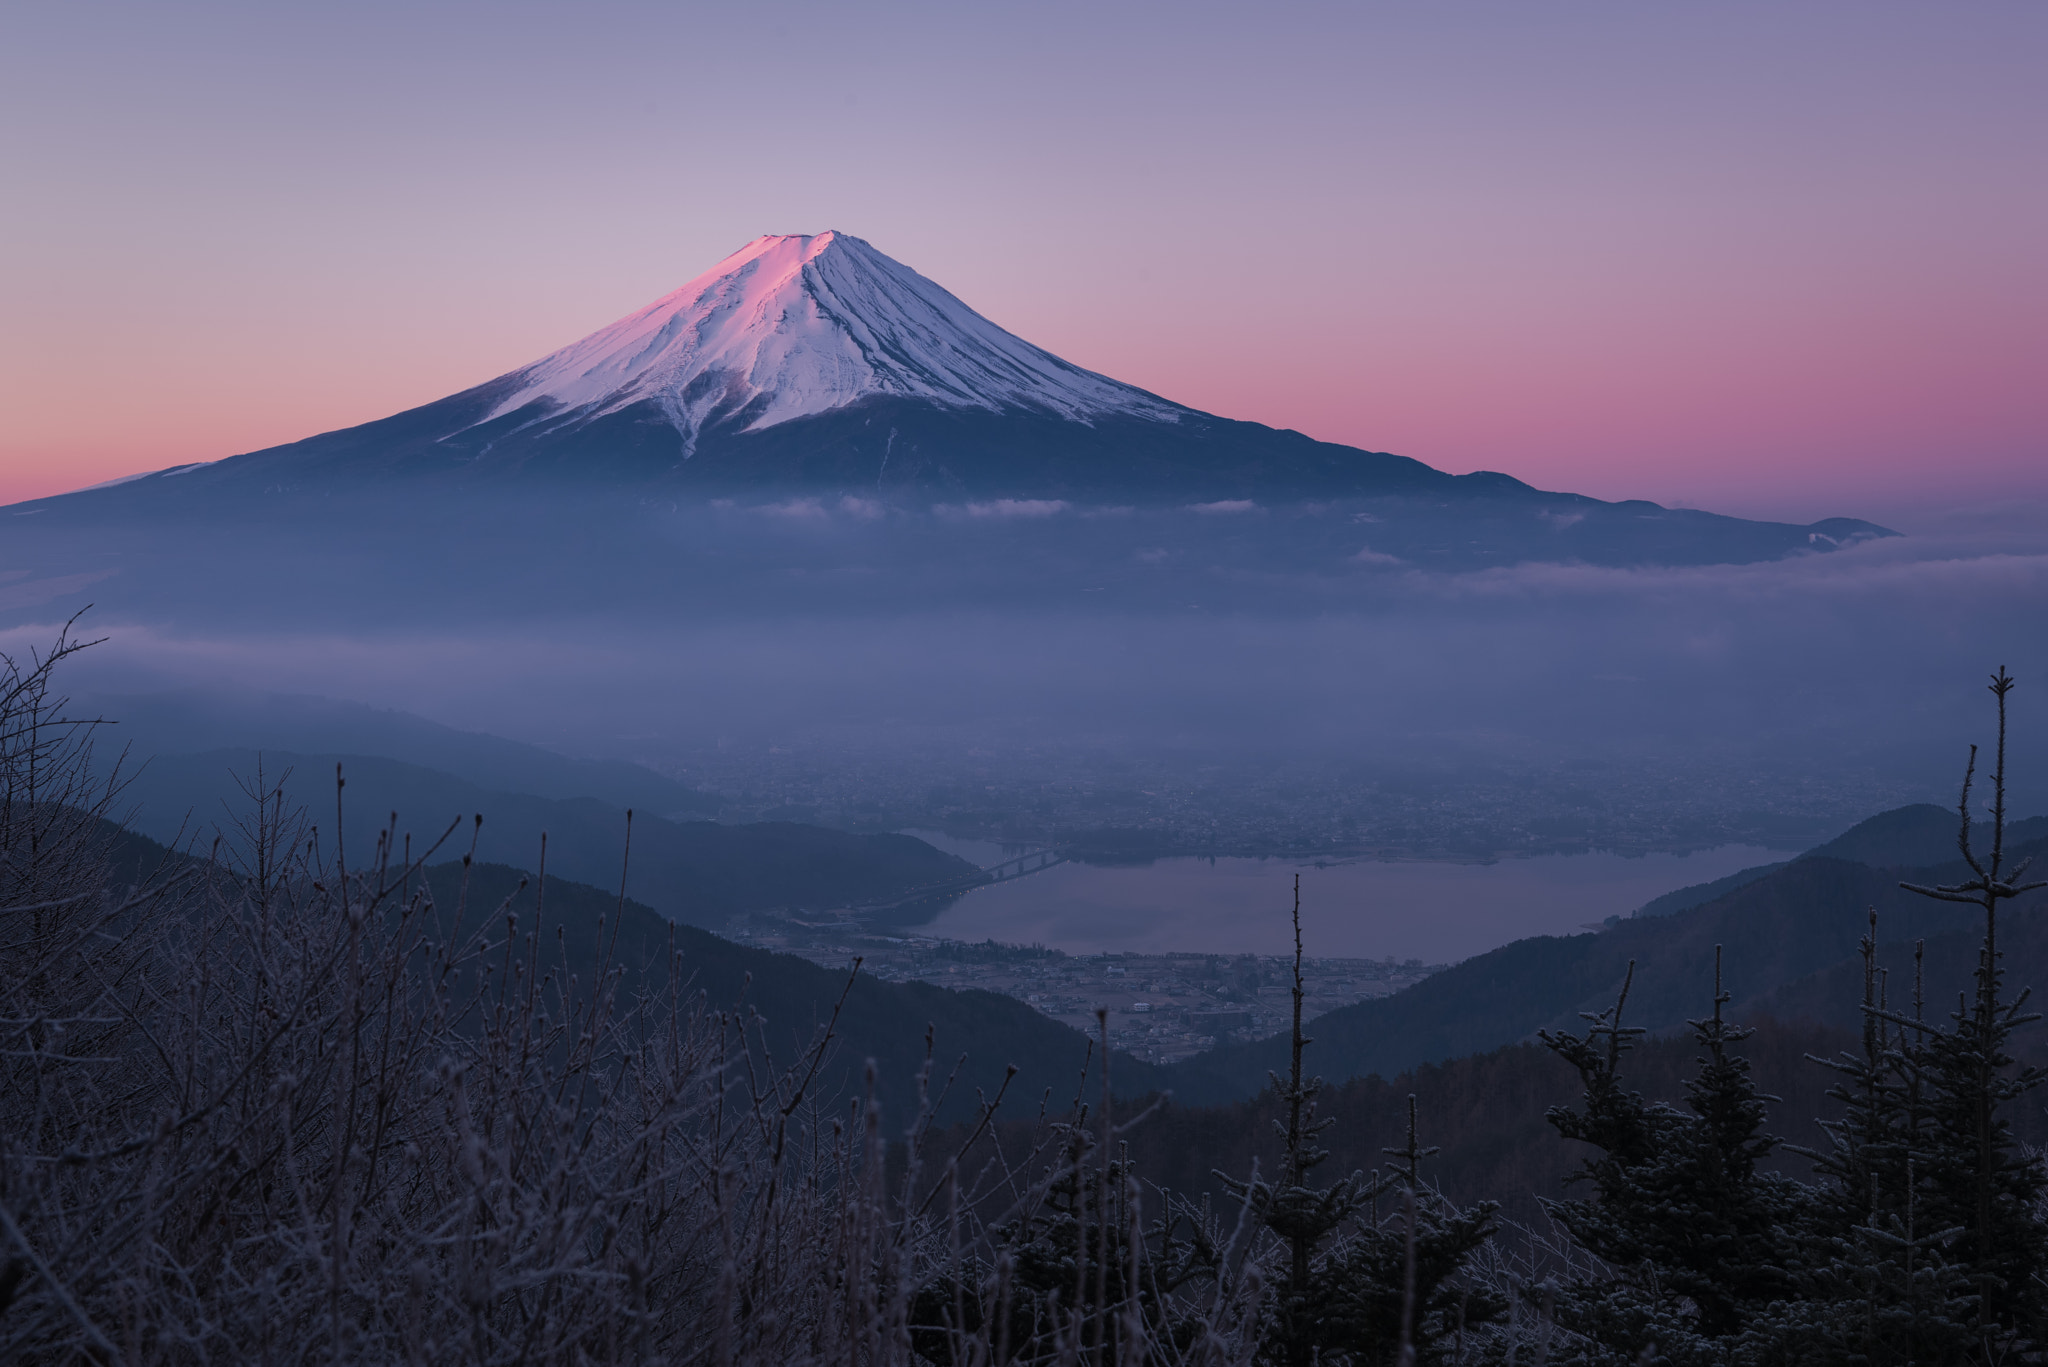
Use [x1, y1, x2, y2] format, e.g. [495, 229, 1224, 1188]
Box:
[485, 232, 1186, 451]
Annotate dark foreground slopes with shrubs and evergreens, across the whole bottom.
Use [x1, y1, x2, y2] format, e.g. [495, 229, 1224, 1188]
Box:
[16, 635, 2048, 1367]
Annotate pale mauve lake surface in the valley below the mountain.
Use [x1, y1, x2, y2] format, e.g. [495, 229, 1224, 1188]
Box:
[907, 830, 1792, 963]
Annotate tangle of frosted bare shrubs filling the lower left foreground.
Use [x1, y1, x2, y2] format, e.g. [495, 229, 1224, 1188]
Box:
[0, 635, 1255, 1367]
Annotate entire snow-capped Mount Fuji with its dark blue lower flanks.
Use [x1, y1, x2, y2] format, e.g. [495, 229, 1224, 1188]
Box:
[16, 232, 1890, 572]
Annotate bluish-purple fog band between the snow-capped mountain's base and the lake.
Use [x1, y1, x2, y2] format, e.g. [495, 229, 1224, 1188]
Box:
[0, 498, 2048, 893]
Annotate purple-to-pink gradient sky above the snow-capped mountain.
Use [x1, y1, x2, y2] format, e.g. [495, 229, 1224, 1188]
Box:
[0, 0, 2048, 516]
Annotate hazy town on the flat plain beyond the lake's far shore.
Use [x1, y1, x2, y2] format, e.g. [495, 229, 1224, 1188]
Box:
[678, 742, 1892, 859]
